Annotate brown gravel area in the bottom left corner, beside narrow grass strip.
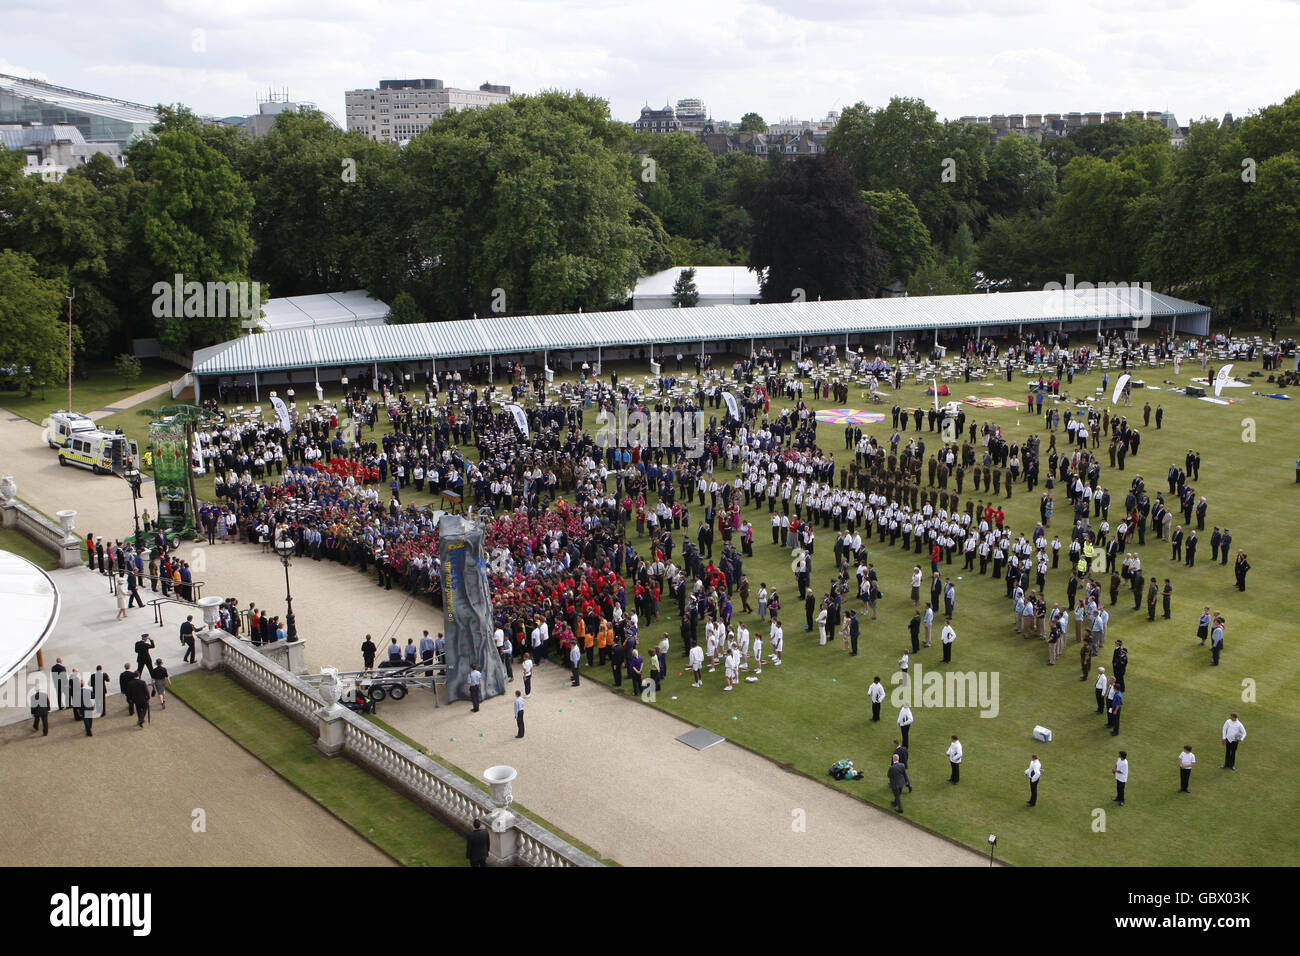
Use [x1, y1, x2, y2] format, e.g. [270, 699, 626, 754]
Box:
[0, 697, 397, 866]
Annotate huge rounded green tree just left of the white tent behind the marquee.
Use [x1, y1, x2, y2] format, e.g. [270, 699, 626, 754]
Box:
[399, 94, 650, 319]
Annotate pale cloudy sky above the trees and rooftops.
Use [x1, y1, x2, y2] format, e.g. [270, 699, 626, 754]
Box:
[0, 0, 1300, 125]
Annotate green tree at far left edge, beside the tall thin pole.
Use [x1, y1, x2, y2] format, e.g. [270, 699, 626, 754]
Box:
[0, 250, 81, 395]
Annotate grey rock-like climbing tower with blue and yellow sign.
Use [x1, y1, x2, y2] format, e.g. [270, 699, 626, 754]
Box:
[438, 514, 506, 701]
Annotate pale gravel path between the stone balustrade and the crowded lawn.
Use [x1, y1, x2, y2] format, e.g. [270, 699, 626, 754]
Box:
[0, 415, 988, 866]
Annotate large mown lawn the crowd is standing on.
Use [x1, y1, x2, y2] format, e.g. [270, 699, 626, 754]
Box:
[50, 335, 1300, 866]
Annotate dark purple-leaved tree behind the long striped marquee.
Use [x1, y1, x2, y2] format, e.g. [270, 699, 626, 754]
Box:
[749, 155, 888, 302]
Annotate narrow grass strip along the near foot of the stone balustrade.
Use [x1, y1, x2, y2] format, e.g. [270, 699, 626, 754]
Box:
[173, 671, 465, 866]
